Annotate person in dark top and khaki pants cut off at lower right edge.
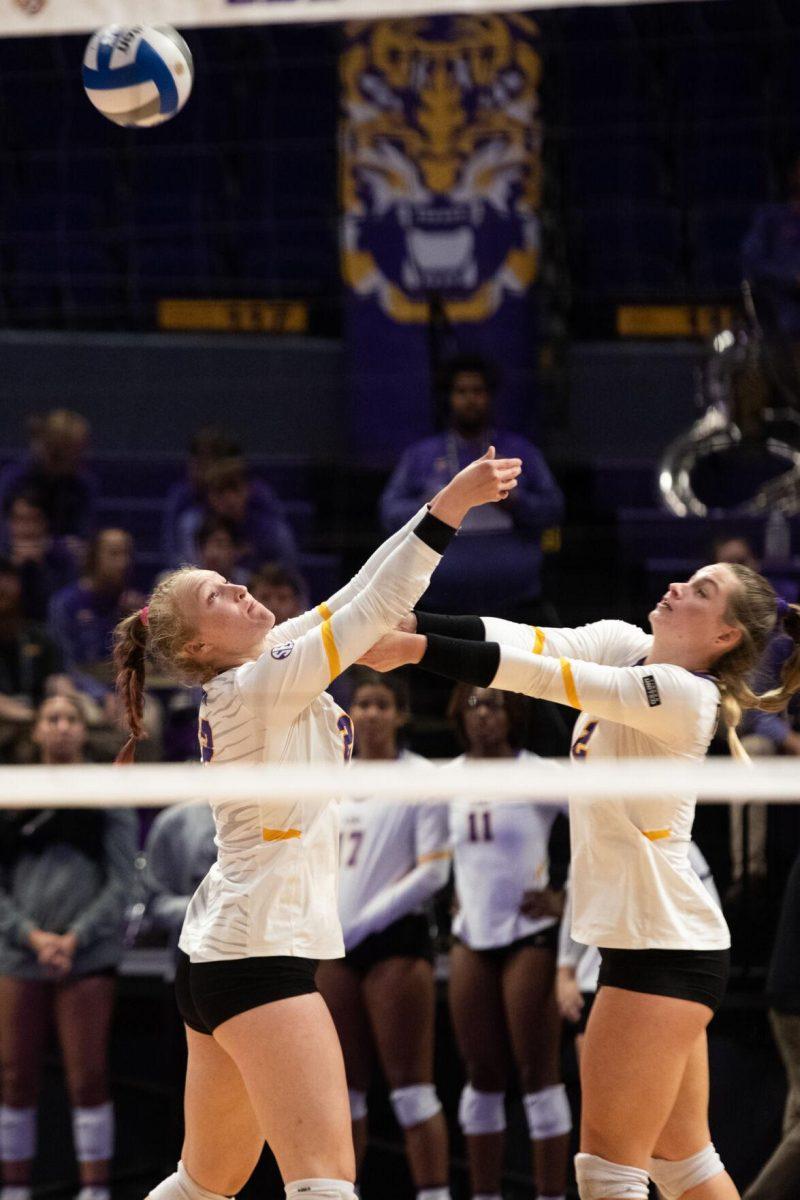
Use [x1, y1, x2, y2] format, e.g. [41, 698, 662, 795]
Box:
[744, 857, 800, 1200]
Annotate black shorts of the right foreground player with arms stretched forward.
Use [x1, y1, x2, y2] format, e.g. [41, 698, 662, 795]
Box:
[597, 947, 730, 1013]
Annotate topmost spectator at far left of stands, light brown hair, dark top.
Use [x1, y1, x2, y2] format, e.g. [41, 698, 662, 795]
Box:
[0, 408, 98, 550]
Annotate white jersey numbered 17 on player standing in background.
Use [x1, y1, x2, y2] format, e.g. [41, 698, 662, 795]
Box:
[339, 750, 450, 950]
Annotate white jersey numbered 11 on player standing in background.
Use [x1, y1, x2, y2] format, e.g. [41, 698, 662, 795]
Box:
[450, 750, 566, 950]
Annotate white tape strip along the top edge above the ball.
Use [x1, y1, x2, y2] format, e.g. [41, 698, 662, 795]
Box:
[0, 0, 705, 37]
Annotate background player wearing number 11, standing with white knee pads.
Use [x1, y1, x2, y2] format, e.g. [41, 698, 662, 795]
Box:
[450, 684, 572, 1200]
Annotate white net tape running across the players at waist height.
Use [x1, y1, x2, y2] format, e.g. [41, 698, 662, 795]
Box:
[0, 758, 800, 809]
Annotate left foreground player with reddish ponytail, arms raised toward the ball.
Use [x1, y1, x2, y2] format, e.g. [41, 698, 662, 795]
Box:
[115, 449, 519, 1200]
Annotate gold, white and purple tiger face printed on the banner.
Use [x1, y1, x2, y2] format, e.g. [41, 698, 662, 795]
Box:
[341, 14, 541, 324]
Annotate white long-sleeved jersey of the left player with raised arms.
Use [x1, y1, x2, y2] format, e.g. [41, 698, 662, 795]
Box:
[179, 514, 441, 961]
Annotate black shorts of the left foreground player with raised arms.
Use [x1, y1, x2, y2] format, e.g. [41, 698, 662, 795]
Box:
[175, 950, 318, 1033]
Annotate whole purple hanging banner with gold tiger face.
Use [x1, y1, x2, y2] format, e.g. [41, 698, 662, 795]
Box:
[341, 13, 541, 463]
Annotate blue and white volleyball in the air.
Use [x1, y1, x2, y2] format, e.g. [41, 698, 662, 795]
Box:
[83, 25, 194, 127]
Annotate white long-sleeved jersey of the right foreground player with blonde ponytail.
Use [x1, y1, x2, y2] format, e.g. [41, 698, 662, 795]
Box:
[483, 618, 730, 950]
